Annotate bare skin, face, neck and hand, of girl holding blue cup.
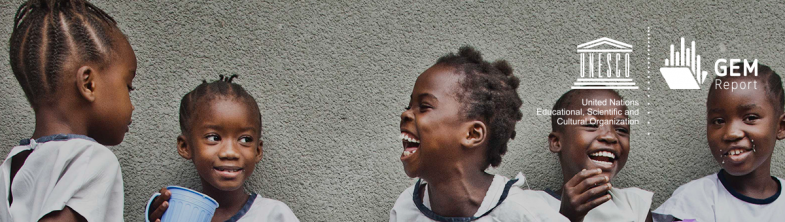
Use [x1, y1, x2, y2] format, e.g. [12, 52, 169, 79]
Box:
[150, 97, 263, 222]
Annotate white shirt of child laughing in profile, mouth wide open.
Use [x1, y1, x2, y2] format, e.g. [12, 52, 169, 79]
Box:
[390, 173, 568, 222]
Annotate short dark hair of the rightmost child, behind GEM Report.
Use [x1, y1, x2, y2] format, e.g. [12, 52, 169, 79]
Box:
[709, 62, 785, 115]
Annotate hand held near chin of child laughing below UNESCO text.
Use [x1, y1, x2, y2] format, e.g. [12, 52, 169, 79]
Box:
[559, 169, 611, 222]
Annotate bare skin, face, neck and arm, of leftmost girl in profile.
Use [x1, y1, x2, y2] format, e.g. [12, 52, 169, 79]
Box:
[9, 30, 136, 221]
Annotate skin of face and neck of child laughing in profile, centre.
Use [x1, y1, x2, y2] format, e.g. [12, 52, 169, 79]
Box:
[401, 64, 493, 217]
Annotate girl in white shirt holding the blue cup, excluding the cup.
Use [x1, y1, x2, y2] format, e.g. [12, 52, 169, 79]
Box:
[145, 75, 299, 222]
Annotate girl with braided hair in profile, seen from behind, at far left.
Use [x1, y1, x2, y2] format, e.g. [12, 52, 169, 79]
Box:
[0, 0, 136, 221]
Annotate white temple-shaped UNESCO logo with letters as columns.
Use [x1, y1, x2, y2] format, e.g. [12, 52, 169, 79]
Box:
[572, 37, 638, 89]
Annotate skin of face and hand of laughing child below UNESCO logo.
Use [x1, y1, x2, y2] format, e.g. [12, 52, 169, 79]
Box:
[548, 90, 651, 221]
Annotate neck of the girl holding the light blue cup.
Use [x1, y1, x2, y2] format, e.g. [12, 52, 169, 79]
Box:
[202, 180, 250, 221]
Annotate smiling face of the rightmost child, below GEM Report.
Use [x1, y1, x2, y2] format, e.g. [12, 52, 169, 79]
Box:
[706, 78, 784, 176]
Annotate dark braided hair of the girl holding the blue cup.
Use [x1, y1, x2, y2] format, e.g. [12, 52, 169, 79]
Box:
[180, 75, 262, 135]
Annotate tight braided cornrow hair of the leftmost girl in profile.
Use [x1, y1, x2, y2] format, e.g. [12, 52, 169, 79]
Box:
[9, 0, 119, 108]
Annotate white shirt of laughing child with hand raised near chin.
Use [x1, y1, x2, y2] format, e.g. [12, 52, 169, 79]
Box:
[524, 187, 654, 222]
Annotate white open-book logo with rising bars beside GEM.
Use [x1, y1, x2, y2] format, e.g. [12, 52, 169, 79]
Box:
[660, 37, 707, 89]
